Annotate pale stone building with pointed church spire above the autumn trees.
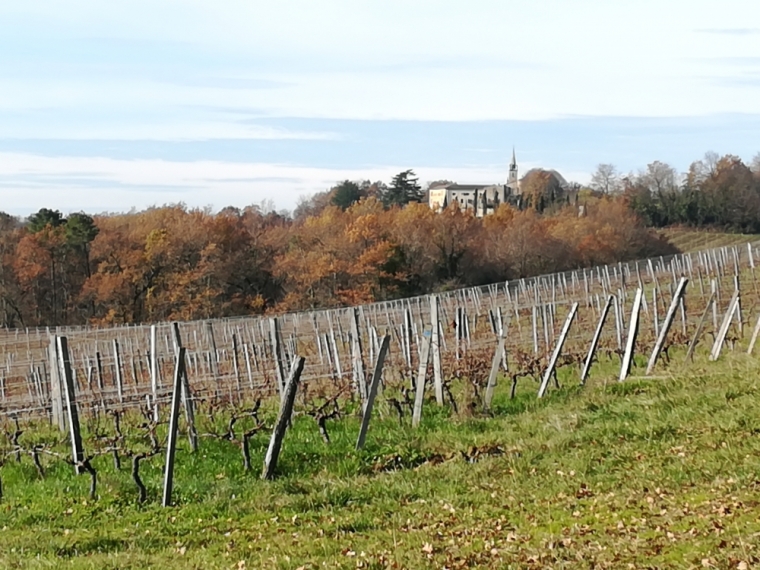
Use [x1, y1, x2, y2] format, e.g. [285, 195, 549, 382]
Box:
[428, 149, 522, 218]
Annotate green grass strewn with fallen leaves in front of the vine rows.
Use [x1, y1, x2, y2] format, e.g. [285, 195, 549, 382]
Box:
[0, 351, 760, 569]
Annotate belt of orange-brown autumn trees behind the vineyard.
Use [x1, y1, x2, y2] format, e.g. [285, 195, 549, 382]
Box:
[0, 153, 760, 327]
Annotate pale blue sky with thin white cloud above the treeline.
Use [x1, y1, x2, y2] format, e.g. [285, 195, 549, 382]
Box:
[0, 0, 760, 216]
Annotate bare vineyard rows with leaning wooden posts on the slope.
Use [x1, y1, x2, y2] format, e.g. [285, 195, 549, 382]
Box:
[0, 243, 760, 568]
